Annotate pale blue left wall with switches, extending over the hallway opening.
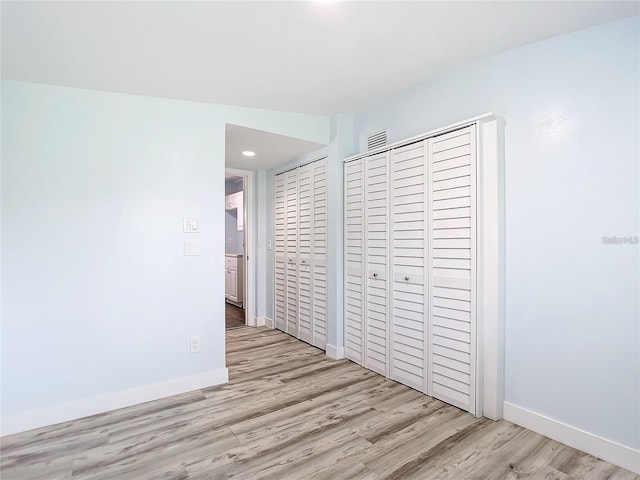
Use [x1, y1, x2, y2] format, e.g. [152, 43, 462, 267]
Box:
[1, 81, 329, 428]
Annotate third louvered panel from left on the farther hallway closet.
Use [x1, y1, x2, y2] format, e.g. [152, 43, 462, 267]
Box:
[298, 165, 313, 343]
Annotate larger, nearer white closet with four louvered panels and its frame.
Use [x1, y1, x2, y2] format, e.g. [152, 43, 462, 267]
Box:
[344, 114, 504, 419]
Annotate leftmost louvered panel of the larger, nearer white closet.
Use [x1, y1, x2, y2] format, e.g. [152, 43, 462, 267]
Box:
[344, 158, 366, 365]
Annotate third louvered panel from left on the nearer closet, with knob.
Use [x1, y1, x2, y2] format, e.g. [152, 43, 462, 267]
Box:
[389, 142, 427, 392]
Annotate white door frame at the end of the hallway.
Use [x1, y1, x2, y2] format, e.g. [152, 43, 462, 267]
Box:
[224, 168, 256, 325]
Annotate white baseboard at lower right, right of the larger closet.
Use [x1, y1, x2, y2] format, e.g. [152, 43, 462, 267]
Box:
[504, 402, 640, 474]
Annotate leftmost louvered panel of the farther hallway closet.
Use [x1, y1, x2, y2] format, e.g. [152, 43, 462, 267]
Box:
[274, 174, 287, 330]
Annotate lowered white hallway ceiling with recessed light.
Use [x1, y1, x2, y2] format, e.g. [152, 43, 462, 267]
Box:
[225, 124, 324, 170]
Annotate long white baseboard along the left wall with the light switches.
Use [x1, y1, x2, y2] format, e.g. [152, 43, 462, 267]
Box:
[0, 368, 229, 436]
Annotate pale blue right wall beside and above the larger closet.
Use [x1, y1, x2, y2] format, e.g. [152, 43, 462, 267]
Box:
[355, 17, 640, 448]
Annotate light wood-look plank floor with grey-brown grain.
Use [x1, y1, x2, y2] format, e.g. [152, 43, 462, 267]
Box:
[1, 328, 640, 480]
